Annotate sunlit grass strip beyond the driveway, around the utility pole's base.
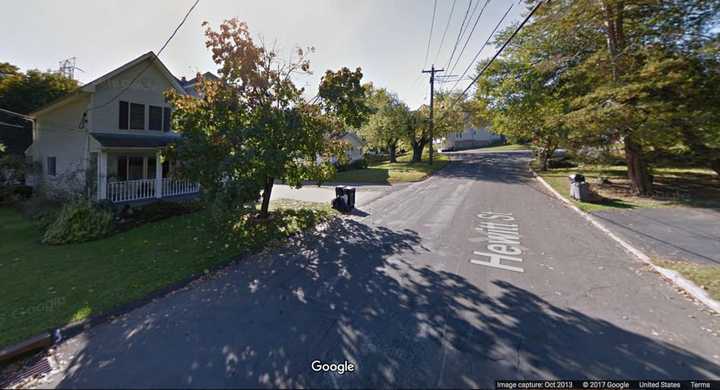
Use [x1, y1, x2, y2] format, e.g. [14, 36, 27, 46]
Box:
[333, 153, 449, 185]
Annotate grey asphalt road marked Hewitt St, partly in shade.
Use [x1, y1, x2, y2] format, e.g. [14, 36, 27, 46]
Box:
[36, 149, 720, 388]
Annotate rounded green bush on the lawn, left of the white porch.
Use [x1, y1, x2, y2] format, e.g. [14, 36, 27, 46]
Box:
[42, 200, 113, 245]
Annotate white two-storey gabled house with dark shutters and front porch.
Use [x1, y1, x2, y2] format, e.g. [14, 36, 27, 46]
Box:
[25, 52, 199, 202]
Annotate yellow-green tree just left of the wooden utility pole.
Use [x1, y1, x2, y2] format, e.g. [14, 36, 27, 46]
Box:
[359, 85, 409, 163]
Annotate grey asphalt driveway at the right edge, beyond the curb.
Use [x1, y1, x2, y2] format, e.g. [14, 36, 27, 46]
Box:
[592, 207, 720, 266]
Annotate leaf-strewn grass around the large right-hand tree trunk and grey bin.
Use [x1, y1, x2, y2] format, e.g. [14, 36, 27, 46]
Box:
[538, 165, 720, 212]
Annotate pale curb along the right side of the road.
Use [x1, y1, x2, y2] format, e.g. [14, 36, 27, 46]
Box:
[530, 169, 720, 313]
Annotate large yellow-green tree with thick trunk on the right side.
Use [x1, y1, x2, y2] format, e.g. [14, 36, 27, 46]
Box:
[478, 0, 720, 187]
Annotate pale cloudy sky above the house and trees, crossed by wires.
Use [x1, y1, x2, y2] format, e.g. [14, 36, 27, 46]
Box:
[0, 0, 526, 108]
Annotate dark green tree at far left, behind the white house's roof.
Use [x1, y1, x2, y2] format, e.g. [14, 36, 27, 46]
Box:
[0, 63, 78, 114]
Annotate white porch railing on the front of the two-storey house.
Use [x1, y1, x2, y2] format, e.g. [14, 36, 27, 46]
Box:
[107, 178, 200, 202]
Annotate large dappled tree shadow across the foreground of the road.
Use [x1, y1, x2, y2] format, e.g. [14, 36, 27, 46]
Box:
[52, 219, 720, 388]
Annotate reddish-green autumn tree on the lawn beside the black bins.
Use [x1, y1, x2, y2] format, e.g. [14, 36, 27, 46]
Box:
[167, 19, 361, 218]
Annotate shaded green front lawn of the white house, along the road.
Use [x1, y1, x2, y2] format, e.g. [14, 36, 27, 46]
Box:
[0, 200, 334, 346]
